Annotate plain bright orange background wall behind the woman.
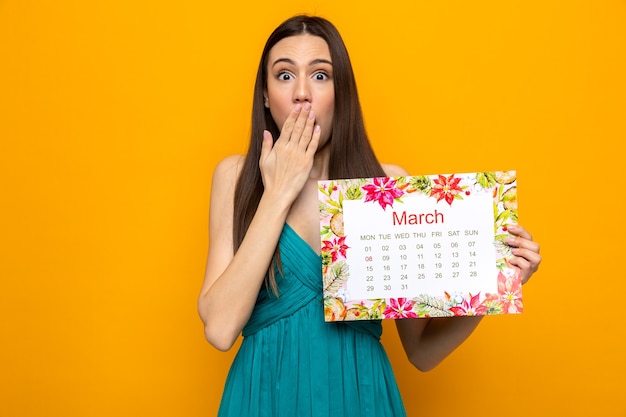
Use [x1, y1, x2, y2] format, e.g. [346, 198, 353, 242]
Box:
[0, 0, 626, 417]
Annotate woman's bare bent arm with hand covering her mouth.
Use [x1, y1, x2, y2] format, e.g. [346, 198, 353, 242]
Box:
[198, 102, 320, 350]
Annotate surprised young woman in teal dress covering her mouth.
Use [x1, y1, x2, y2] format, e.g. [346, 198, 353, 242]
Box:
[198, 16, 541, 417]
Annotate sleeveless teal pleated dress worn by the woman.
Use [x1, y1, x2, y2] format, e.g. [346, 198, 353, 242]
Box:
[218, 224, 406, 417]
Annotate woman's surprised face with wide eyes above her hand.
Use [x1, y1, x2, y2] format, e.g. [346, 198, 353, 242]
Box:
[265, 35, 335, 148]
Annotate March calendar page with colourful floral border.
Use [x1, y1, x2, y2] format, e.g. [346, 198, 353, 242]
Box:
[318, 171, 523, 321]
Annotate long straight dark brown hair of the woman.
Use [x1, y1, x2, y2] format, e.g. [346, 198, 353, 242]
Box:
[233, 15, 385, 292]
